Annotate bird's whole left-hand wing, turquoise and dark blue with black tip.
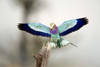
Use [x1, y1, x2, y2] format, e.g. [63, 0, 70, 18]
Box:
[18, 23, 51, 37]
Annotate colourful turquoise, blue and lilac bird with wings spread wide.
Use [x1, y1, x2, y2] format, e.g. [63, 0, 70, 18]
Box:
[18, 17, 88, 48]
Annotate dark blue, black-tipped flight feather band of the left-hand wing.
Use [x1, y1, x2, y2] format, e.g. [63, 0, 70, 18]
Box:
[18, 23, 51, 37]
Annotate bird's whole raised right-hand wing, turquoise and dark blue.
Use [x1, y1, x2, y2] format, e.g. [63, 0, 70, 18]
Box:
[58, 17, 88, 36]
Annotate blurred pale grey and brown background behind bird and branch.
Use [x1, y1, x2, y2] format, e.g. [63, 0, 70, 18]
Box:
[0, 0, 100, 67]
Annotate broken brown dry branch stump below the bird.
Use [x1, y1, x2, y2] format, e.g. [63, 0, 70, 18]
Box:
[33, 43, 51, 67]
